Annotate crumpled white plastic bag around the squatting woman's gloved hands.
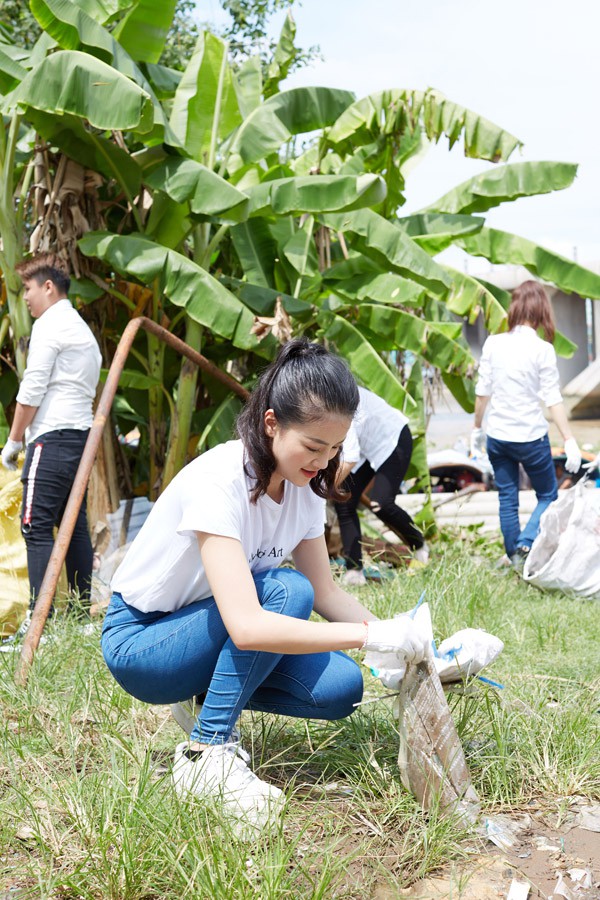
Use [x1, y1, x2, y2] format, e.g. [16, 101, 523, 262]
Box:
[364, 598, 504, 691]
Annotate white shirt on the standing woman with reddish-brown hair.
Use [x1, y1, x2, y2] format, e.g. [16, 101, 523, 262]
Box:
[475, 325, 562, 443]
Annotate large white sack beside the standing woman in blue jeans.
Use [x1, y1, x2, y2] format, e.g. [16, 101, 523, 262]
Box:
[523, 481, 600, 598]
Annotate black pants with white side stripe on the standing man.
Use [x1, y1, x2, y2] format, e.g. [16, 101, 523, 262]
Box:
[21, 428, 94, 609]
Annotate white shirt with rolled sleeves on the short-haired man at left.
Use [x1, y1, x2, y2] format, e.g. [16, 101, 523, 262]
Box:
[17, 298, 102, 443]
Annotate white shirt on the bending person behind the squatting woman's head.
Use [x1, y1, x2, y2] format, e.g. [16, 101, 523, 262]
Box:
[343, 387, 408, 472]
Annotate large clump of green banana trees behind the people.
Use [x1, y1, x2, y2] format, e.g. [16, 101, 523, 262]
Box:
[0, 0, 597, 536]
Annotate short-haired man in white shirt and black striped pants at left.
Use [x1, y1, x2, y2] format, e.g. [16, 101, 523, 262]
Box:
[2, 253, 101, 620]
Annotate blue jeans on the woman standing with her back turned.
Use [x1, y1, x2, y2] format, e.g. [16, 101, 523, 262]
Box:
[487, 434, 558, 556]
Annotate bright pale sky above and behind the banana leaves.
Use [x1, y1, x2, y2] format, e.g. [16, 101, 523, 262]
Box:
[198, 0, 600, 265]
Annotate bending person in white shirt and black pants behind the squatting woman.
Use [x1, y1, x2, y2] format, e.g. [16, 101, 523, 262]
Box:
[335, 387, 429, 586]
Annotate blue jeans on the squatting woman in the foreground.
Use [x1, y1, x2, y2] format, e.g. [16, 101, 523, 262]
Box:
[102, 569, 363, 744]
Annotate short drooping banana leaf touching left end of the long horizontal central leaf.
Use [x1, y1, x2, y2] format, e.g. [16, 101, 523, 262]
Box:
[144, 156, 250, 224]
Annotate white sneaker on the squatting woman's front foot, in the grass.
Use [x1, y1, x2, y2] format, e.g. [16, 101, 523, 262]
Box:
[173, 741, 285, 840]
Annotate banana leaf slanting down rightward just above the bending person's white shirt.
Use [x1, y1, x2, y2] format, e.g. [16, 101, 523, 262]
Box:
[324, 316, 415, 415]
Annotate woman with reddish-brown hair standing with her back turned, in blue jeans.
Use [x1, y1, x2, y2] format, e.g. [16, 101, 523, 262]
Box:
[471, 281, 581, 569]
